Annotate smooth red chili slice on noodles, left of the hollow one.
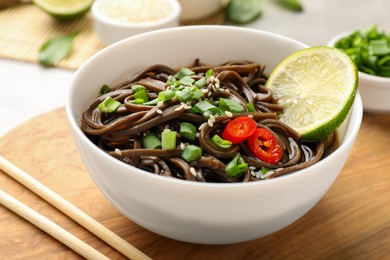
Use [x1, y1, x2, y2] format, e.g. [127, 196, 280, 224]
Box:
[222, 116, 257, 144]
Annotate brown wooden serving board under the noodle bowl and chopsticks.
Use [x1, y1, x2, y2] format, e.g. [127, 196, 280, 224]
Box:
[0, 108, 390, 259]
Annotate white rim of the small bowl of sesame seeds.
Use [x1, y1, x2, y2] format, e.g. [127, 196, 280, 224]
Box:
[91, 0, 181, 29]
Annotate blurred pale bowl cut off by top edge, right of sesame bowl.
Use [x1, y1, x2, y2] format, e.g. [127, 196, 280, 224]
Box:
[178, 0, 222, 21]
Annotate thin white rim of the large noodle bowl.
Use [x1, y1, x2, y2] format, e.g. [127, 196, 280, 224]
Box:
[66, 25, 363, 189]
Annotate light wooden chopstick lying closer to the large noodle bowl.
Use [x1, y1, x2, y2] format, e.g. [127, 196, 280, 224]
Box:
[0, 155, 151, 259]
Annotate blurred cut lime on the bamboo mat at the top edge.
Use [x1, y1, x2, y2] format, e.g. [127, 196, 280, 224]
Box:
[33, 0, 93, 20]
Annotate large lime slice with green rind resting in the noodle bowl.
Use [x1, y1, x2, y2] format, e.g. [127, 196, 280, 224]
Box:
[266, 46, 358, 141]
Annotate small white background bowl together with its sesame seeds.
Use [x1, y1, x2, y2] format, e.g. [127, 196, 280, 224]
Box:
[91, 0, 181, 45]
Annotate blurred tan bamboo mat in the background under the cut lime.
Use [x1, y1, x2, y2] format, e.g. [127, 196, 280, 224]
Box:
[0, 4, 224, 70]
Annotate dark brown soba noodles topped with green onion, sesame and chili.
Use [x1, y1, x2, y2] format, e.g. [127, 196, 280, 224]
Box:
[81, 60, 336, 182]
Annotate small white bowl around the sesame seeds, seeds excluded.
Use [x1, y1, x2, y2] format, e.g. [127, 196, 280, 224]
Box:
[91, 0, 181, 45]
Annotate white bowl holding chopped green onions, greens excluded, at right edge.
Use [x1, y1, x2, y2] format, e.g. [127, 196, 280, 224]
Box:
[328, 32, 390, 112]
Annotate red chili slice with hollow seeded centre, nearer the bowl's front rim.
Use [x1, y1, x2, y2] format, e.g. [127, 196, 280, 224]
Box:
[247, 128, 282, 164]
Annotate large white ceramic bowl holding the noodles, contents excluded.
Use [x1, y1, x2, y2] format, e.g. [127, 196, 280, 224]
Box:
[67, 26, 362, 244]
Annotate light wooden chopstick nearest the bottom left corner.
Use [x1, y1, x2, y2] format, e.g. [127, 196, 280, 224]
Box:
[0, 190, 109, 260]
